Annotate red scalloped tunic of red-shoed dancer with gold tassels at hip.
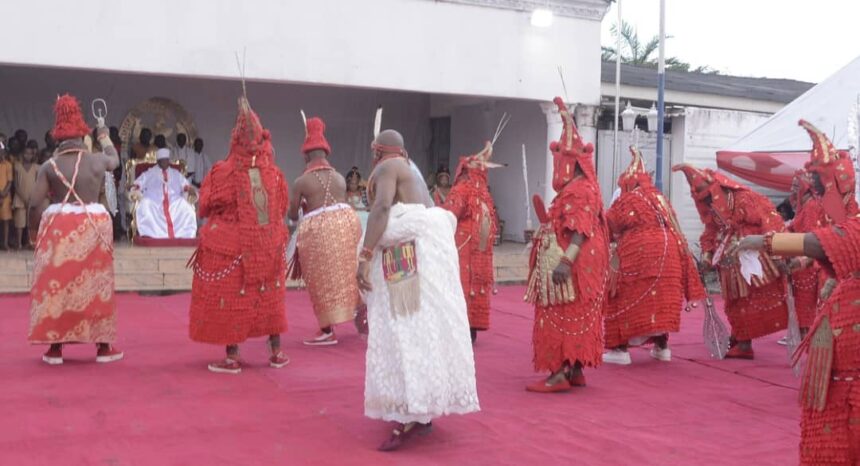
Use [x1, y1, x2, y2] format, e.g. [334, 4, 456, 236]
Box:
[527, 177, 609, 372]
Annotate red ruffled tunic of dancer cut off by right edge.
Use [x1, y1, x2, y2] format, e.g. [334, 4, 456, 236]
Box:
[800, 216, 860, 465]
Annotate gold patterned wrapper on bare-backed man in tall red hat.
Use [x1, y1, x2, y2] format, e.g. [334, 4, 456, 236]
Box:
[296, 204, 361, 328]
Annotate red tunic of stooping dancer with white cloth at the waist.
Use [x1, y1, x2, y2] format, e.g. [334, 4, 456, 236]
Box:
[700, 189, 788, 341]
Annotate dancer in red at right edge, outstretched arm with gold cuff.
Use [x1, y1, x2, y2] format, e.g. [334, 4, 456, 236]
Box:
[739, 219, 860, 466]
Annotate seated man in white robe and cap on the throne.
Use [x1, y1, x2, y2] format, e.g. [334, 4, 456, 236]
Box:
[130, 149, 197, 239]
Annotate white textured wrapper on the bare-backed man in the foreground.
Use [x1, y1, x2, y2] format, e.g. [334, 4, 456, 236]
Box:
[364, 203, 480, 423]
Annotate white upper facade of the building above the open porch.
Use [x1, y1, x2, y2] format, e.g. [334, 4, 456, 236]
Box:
[0, 0, 608, 104]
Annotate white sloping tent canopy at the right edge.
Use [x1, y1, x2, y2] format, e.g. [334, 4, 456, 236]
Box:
[725, 57, 860, 152]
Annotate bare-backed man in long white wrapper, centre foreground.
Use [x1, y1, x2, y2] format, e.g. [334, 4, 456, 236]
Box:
[356, 130, 480, 451]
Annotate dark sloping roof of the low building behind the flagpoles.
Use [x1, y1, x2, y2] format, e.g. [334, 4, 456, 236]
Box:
[600, 62, 815, 104]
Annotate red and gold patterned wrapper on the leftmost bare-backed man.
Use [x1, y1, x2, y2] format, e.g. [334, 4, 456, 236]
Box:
[28, 204, 116, 344]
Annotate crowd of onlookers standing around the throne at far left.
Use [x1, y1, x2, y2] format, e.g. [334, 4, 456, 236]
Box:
[0, 126, 212, 251]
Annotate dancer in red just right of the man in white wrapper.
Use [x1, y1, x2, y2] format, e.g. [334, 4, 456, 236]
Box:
[443, 142, 502, 343]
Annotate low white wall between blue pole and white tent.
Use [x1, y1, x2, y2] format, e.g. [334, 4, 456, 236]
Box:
[671, 107, 770, 253]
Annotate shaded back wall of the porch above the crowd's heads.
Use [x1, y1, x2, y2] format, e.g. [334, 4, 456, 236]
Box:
[0, 66, 430, 180]
